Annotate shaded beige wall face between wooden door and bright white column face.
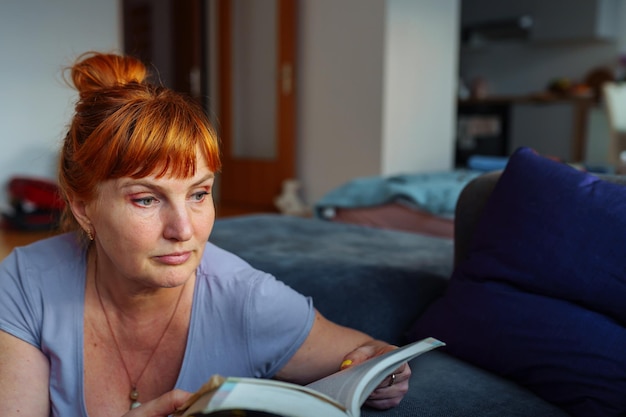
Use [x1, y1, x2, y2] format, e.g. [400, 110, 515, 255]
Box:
[296, 0, 386, 204]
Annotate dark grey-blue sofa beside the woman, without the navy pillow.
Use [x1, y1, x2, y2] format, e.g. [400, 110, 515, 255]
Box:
[210, 168, 568, 417]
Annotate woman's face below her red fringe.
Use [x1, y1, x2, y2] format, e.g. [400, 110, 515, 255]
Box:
[85, 153, 215, 289]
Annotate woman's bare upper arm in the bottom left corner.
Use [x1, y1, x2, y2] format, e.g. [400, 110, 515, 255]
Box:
[0, 330, 50, 417]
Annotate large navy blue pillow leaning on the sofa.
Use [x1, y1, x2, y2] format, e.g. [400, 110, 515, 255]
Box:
[411, 148, 626, 417]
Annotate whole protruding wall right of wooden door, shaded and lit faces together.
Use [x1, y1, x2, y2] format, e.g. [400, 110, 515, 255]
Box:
[297, 0, 460, 204]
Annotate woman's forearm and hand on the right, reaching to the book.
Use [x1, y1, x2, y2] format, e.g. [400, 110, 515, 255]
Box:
[276, 311, 411, 409]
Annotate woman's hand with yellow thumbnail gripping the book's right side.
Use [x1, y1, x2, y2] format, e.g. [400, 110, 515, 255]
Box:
[341, 340, 411, 410]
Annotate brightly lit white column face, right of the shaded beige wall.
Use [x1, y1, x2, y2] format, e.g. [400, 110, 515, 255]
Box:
[381, 0, 460, 175]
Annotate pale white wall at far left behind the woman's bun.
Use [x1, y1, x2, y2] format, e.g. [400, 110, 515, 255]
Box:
[0, 0, 122, 205]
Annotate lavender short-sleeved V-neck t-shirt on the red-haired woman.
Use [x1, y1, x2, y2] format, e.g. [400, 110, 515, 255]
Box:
[0, 234, 315, 416]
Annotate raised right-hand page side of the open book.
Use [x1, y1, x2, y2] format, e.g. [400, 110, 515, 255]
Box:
[307, 337, 445, 417]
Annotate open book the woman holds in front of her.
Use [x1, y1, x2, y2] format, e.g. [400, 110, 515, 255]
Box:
[173, 338, 445, 417]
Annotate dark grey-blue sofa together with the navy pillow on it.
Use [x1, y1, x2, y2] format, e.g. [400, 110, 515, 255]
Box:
[211, 141, 626, 417]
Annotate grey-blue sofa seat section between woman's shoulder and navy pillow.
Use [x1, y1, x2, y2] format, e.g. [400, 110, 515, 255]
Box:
[210, 215, 452, 344]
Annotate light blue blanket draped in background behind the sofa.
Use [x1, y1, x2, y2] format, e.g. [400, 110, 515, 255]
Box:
[315, 169, 484, 218]
